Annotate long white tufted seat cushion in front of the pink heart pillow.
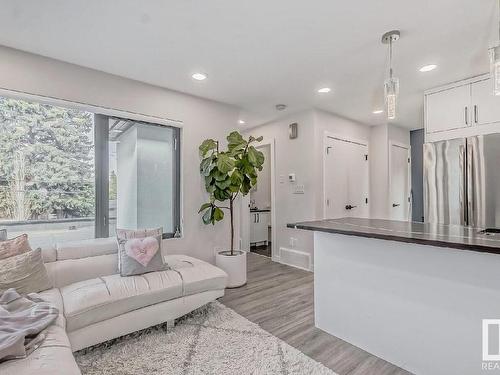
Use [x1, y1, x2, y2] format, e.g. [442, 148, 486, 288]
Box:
[61, 270, 182, 332]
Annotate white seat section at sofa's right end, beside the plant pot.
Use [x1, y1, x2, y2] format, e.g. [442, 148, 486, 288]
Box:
[165, 255, 227, 296]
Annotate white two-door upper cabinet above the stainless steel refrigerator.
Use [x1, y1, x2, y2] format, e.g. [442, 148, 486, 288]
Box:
[424, 74, 500, 142]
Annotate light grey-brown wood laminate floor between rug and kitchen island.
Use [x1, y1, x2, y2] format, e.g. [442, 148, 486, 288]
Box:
[221, 253, 410, 375]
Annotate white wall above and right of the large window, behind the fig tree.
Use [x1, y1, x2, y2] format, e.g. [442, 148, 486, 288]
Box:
[0, 47, 239, 261]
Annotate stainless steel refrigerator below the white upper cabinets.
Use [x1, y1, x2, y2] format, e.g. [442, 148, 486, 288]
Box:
[423, 134, 500, 229]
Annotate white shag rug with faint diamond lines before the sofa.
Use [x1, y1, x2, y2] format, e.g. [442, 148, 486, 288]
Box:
[75, 302, 335, 375]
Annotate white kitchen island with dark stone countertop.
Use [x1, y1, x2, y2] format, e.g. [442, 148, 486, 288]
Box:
[288, 218, 500, 374]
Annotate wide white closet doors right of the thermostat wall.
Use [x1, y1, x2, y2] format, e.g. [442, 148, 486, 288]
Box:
[324, 137, 369, 219]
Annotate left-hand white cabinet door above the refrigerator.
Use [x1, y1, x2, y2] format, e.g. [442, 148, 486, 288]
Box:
[425, 84, 472, 133]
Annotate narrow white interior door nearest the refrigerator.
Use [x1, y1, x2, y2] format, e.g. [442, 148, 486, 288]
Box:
[389, 144, 411, 221]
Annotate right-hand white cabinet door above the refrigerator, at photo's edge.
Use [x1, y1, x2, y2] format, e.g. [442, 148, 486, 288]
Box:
[472, 79, 500, 125]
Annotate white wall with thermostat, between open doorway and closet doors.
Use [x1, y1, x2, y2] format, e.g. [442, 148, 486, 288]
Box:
[248, 110, 370, 268]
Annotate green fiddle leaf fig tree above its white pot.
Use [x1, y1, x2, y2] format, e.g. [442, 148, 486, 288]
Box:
[198, 131, 264, 255]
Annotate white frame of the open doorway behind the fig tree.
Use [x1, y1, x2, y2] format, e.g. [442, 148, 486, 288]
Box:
[240, 138, 279, 261]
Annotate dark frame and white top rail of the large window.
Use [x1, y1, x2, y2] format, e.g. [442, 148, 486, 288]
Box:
[0, 88, 184, 239]
